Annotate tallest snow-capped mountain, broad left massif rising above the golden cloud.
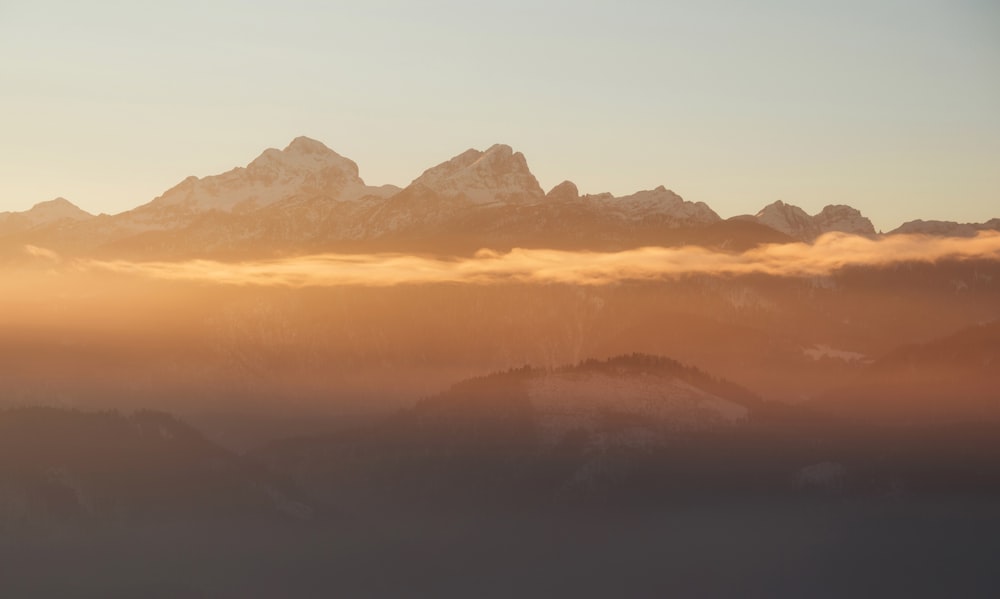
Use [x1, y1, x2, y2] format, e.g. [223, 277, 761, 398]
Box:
[0, 137, 400, 258]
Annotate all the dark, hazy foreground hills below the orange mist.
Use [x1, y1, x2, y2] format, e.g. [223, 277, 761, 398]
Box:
[0, 355, 1000, 598]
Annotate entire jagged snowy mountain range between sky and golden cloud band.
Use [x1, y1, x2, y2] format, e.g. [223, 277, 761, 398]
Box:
[0, 137, 1000, 258]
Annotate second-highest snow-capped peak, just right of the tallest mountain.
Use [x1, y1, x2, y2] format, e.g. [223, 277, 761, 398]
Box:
[413, 144, 545, 204]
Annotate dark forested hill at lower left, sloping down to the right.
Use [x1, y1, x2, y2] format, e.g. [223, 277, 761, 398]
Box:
[0, 408, 313, 530]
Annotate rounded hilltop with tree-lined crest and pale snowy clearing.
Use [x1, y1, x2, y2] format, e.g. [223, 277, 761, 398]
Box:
[413, 354, 760, 447]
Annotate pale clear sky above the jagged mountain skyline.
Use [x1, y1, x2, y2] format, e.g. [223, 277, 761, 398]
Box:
[0, 0, 1000, 230]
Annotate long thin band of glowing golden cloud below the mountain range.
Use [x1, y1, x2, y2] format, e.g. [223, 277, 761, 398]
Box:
[27, 232, 1000, 288]
